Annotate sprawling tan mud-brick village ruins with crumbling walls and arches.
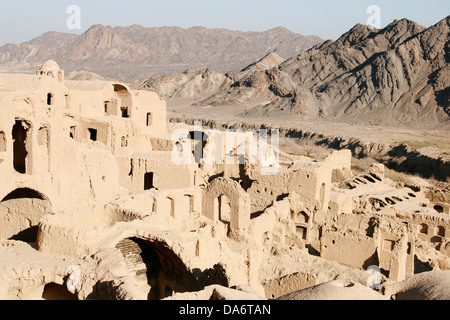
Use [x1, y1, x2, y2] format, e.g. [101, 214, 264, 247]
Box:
[0, 61, 450, 300]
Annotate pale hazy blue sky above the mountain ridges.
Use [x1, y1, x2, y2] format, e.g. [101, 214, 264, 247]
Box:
[0, 0, 450, 45]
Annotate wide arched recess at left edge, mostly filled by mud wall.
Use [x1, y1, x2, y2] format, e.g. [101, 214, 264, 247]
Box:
[0, 188, 51, 243]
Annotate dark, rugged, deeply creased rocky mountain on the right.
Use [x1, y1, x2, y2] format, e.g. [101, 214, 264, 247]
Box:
[168, 17, 450, 127]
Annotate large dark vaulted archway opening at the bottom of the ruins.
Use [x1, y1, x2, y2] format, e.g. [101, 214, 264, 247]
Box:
[116, 237, 199, 300]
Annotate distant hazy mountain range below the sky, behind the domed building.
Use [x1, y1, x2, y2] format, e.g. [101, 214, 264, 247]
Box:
[0, 25, 322, 81]
